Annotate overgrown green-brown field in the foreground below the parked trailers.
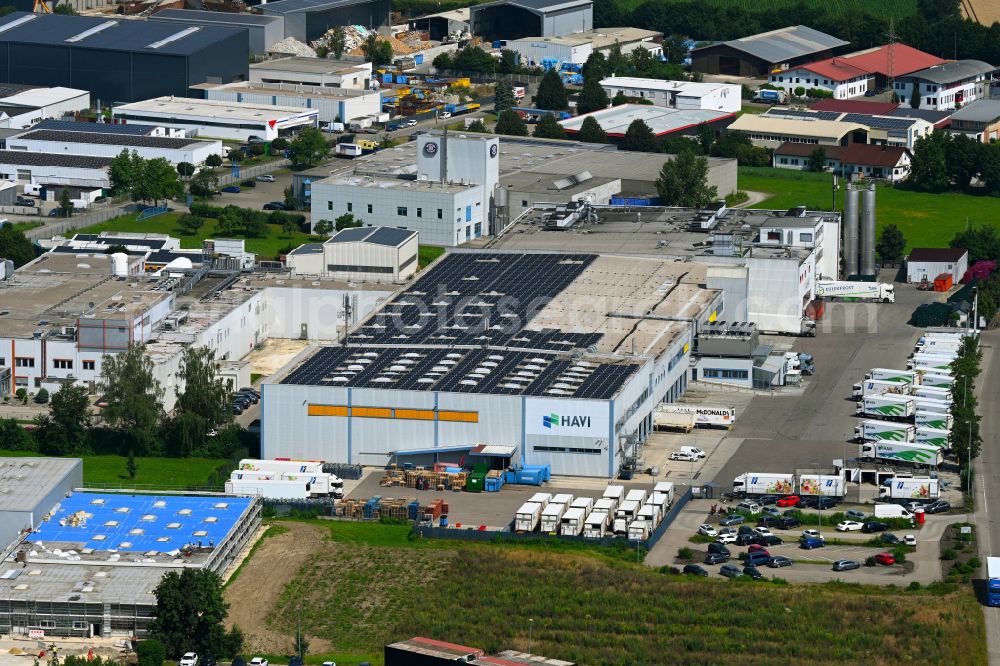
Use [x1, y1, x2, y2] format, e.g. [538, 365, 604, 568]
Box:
[226, 521, 986, 665]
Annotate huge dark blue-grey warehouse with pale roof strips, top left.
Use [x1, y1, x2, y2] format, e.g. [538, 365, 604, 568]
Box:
[0, 12, 250, 105]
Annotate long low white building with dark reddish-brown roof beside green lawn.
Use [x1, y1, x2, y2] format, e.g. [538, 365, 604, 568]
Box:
[774, 143, 910, 182]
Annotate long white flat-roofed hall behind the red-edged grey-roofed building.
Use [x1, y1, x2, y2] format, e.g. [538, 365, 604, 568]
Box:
[601, 76, 742, 113]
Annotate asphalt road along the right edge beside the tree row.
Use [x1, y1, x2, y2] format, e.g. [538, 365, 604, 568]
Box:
[974, 331, 1000, 664]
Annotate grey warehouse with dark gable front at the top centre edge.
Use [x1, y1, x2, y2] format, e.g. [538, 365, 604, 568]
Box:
[470, 0, 594, 41]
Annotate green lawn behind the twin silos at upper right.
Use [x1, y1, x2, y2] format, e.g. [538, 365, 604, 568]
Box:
[739, 167, 1000, 250]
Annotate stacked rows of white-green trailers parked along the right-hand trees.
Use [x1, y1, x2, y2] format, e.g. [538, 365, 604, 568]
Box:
[854, 329, 976, 466]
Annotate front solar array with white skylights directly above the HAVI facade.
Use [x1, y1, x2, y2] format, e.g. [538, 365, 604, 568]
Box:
[281, 347, 639, 400]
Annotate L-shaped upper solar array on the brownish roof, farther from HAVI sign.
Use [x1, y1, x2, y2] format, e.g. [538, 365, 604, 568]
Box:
[350, 253, 601, 351]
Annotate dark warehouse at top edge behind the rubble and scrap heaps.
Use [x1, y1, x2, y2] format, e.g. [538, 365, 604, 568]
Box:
[260, 0, 390, 42]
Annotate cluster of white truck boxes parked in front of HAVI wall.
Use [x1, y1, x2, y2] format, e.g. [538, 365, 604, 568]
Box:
[514, 481, 674, 541]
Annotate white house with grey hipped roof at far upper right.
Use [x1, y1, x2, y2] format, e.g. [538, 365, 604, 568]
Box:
[895, 60, 996, 111]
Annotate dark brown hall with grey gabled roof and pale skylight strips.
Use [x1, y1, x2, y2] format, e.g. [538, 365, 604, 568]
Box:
[691, 25, 848, 78]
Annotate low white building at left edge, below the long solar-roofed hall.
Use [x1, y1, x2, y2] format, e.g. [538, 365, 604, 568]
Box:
[0, 150, 111, 189]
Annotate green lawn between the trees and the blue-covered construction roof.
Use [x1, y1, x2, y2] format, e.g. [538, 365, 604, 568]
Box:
[0, 451, 226, 490]
